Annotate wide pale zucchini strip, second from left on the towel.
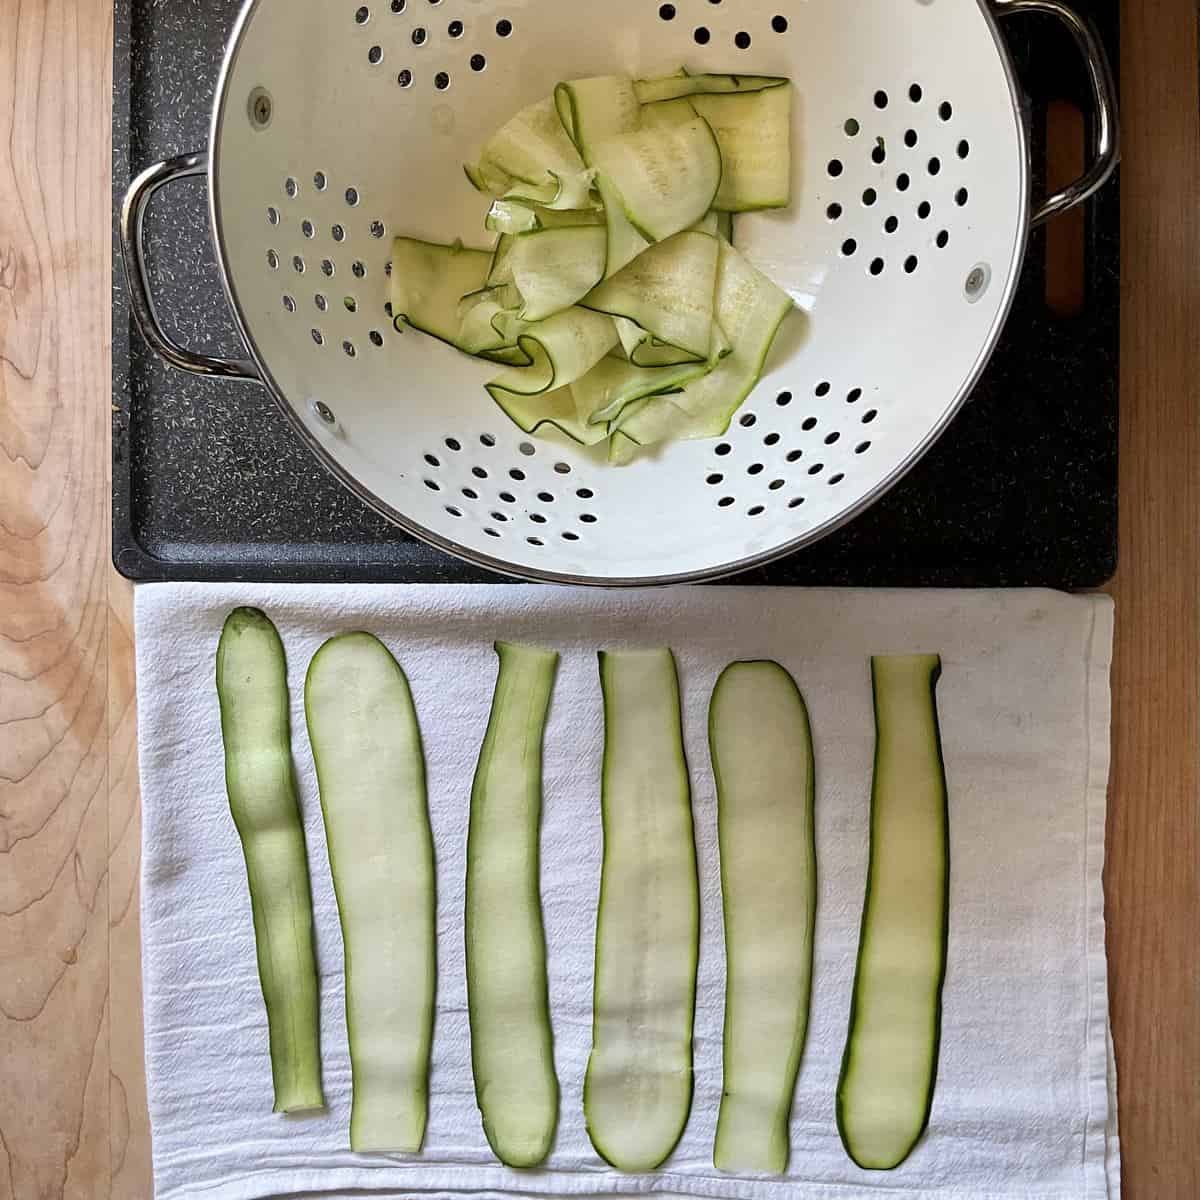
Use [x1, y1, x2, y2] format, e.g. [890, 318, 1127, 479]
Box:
[305, 634, 437, 1153]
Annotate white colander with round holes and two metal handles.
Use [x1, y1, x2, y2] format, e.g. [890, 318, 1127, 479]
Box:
[122, 0, 1117, 584]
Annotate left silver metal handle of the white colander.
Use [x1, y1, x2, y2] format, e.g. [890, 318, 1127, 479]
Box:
[121, 154, 260, 382]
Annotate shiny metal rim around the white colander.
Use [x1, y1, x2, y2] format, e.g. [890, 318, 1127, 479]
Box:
[194, 0, 1070, 588]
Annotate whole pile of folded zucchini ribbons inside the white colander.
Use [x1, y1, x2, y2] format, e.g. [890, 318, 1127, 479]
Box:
[391, 71, 792, 463]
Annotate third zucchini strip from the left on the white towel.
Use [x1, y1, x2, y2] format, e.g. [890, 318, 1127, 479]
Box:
[466, 642, 558, 1166]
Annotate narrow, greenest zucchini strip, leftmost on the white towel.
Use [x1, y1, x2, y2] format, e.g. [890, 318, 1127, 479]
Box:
[216, 608, 325, 1112]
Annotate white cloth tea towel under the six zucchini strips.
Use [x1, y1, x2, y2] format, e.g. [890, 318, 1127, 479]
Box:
[137, 584, 1117, 1200]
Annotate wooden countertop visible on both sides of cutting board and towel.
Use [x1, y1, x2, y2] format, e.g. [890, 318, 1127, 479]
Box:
[0, 0, 1200, 1200]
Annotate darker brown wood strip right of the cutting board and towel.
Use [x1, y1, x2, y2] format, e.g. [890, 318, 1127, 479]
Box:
[1106, 0, 1200, 1200]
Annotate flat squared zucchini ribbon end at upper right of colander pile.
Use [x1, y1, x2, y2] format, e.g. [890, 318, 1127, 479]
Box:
[691, 84, 792, 212]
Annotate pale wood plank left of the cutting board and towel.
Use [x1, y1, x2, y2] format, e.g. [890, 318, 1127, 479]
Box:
[0, 0, 112, 1200]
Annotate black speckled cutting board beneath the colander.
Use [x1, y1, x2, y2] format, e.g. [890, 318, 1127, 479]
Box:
[113, 0, 1120, 588]
